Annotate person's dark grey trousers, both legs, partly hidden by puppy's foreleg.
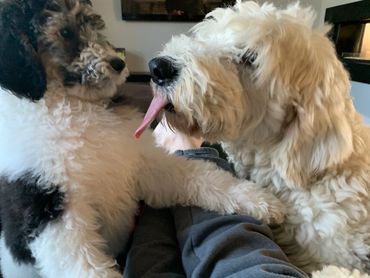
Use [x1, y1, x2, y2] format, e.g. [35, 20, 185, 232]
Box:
[124, 148, 308, 278]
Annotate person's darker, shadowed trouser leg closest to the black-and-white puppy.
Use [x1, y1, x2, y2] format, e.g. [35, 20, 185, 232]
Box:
[124, 206, 185, 278]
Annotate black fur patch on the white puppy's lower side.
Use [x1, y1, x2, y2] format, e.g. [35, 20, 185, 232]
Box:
[0, 174, 64, 263]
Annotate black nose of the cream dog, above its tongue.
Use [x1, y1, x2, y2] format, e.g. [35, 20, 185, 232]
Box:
[149, 57, 178, 86]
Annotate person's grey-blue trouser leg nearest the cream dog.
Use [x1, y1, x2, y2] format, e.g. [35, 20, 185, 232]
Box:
[172, 207, 308, 278]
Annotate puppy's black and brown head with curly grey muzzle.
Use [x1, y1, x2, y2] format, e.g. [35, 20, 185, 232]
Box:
[0, 0, 128, 100]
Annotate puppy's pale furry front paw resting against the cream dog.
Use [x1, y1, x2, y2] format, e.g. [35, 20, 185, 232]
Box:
[231, 182, 286, 224]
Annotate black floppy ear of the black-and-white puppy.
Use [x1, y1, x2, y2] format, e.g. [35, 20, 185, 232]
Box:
[0, 0, 46, 100]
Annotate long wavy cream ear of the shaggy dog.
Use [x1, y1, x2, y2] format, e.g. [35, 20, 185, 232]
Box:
[272, 71, 352, 189]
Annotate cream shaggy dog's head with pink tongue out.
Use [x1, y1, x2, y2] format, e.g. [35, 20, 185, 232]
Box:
[138, 1, 355, 188]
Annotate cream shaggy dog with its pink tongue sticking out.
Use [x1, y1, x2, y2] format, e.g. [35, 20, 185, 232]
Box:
[137, 1, 370, 272]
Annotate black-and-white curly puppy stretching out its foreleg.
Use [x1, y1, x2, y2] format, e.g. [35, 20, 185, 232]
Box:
[0, 0, 283, 278]
